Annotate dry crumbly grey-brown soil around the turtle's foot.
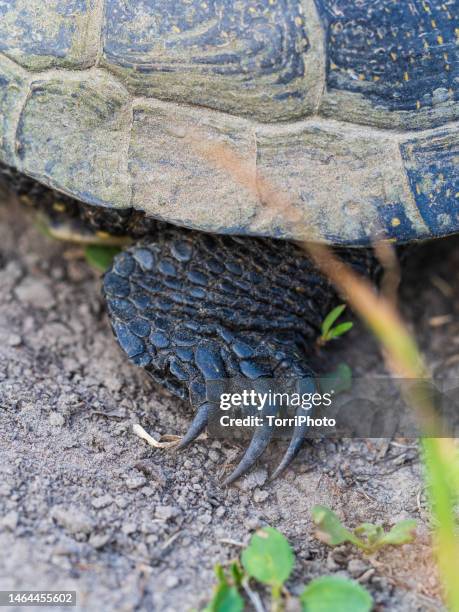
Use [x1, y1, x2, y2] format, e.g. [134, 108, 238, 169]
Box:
[0, 196, 459, 611]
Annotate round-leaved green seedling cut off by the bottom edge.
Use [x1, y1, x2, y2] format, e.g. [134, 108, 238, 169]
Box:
[203, 527, 373, 612]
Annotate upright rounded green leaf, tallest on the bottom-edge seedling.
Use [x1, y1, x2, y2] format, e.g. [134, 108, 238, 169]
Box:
[241, 527, 295, 587]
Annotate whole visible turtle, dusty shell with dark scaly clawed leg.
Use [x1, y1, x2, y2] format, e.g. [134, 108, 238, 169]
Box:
[0, 0, 459, 482]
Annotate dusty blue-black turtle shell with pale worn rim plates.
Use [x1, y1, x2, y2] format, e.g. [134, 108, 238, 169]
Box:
[0, 0, 459, 246]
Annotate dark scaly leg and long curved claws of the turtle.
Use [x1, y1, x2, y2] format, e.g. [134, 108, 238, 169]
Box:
[104, 226, 371, 484]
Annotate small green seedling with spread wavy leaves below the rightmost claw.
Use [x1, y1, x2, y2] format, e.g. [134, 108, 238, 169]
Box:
[312, 506, 416, 554]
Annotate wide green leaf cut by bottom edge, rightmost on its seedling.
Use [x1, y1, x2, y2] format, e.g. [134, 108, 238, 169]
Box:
[300, 576, 373, 612]
